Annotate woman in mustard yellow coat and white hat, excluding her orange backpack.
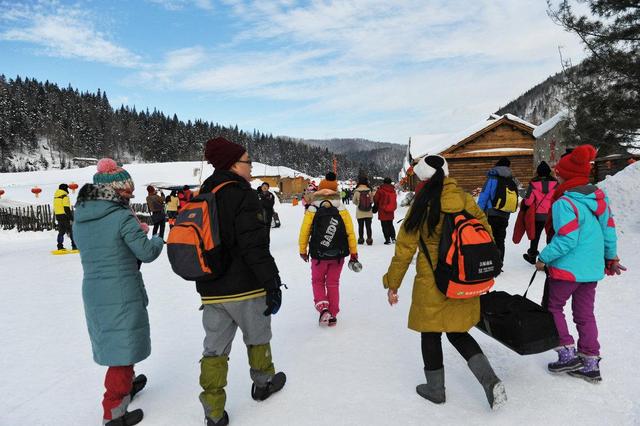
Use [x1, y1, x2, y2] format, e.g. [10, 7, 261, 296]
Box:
[383, 155, 507, 409]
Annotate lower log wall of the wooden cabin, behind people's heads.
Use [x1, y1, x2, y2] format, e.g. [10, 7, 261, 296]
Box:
[447, 155, 535, 192]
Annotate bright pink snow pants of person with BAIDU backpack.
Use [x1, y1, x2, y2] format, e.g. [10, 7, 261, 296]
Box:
[311, 259, 344, 317]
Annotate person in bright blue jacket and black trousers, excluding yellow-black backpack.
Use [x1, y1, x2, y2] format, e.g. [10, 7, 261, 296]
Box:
[478, 157, 517, 263]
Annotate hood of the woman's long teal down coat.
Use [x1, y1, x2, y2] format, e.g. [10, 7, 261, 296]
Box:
[75, 183, 129, 222]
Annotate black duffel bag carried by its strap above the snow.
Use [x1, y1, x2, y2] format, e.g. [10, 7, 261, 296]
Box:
[476, 272, 558, 355]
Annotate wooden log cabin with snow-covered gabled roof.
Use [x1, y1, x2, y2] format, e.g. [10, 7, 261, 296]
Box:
[407, 114, 536, 192]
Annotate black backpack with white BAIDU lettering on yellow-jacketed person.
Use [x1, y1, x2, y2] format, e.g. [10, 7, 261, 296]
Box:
[309, 200, 349, 260]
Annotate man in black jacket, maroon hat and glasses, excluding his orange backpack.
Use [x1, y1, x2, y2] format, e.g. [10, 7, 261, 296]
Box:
[196, 137, 286, 426]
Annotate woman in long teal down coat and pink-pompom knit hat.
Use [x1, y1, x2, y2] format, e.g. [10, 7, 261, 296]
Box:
[73, 158, 163, 426]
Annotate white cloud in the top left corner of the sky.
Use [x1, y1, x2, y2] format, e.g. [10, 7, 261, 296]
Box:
[0, 2, 142, 68]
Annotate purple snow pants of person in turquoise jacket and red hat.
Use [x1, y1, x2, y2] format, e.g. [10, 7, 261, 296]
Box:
[548, 278, 600, 356]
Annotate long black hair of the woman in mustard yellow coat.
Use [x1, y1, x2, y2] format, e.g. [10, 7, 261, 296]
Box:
[404, 167, 444, 236]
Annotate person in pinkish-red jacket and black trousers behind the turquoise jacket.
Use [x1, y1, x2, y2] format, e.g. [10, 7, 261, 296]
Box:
[522, 161, 558, 265]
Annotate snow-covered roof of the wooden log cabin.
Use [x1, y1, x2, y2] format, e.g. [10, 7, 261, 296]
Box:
[409, 114, 536, 158]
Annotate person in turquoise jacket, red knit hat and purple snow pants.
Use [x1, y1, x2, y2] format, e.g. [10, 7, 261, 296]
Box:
[536, 145, 626, 383]
